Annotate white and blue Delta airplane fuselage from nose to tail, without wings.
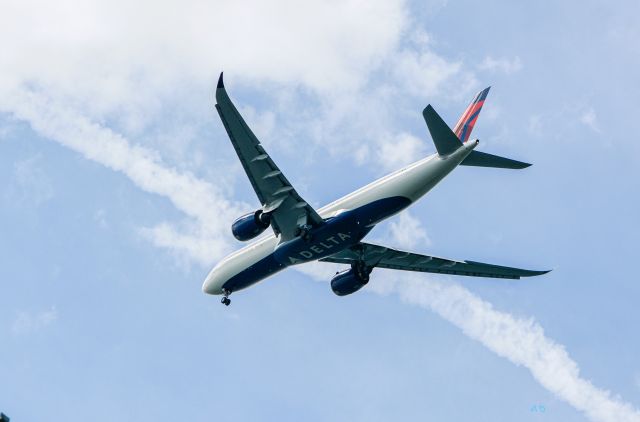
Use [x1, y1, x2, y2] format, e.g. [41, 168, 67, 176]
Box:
[202, 140, 478, 294]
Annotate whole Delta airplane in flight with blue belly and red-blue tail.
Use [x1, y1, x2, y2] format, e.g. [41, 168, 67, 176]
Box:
[202, 73, 548, 306]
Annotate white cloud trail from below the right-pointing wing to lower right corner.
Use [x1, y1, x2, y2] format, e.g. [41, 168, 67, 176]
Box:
[368, 221, 640, 422]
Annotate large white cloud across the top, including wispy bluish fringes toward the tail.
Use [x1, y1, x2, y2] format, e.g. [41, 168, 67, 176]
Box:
[0, 0, 482, 168]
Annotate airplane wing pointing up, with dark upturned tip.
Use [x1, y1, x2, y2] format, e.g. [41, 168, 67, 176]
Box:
[216, 73, 323, 240]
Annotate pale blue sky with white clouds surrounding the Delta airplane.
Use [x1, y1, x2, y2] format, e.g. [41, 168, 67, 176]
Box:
[0, 0, 640, 422]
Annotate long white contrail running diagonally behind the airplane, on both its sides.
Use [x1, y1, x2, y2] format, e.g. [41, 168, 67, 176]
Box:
[5, 91, 640, 422]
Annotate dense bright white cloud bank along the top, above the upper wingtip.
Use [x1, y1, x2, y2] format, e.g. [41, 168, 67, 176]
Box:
[0, 0, 406, 118]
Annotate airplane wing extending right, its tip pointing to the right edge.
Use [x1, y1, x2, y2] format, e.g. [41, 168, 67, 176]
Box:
[320, 243, 549, 279]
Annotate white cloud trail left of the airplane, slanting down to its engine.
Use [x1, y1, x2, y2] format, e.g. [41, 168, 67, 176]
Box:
[0, 90, 250, 264]
